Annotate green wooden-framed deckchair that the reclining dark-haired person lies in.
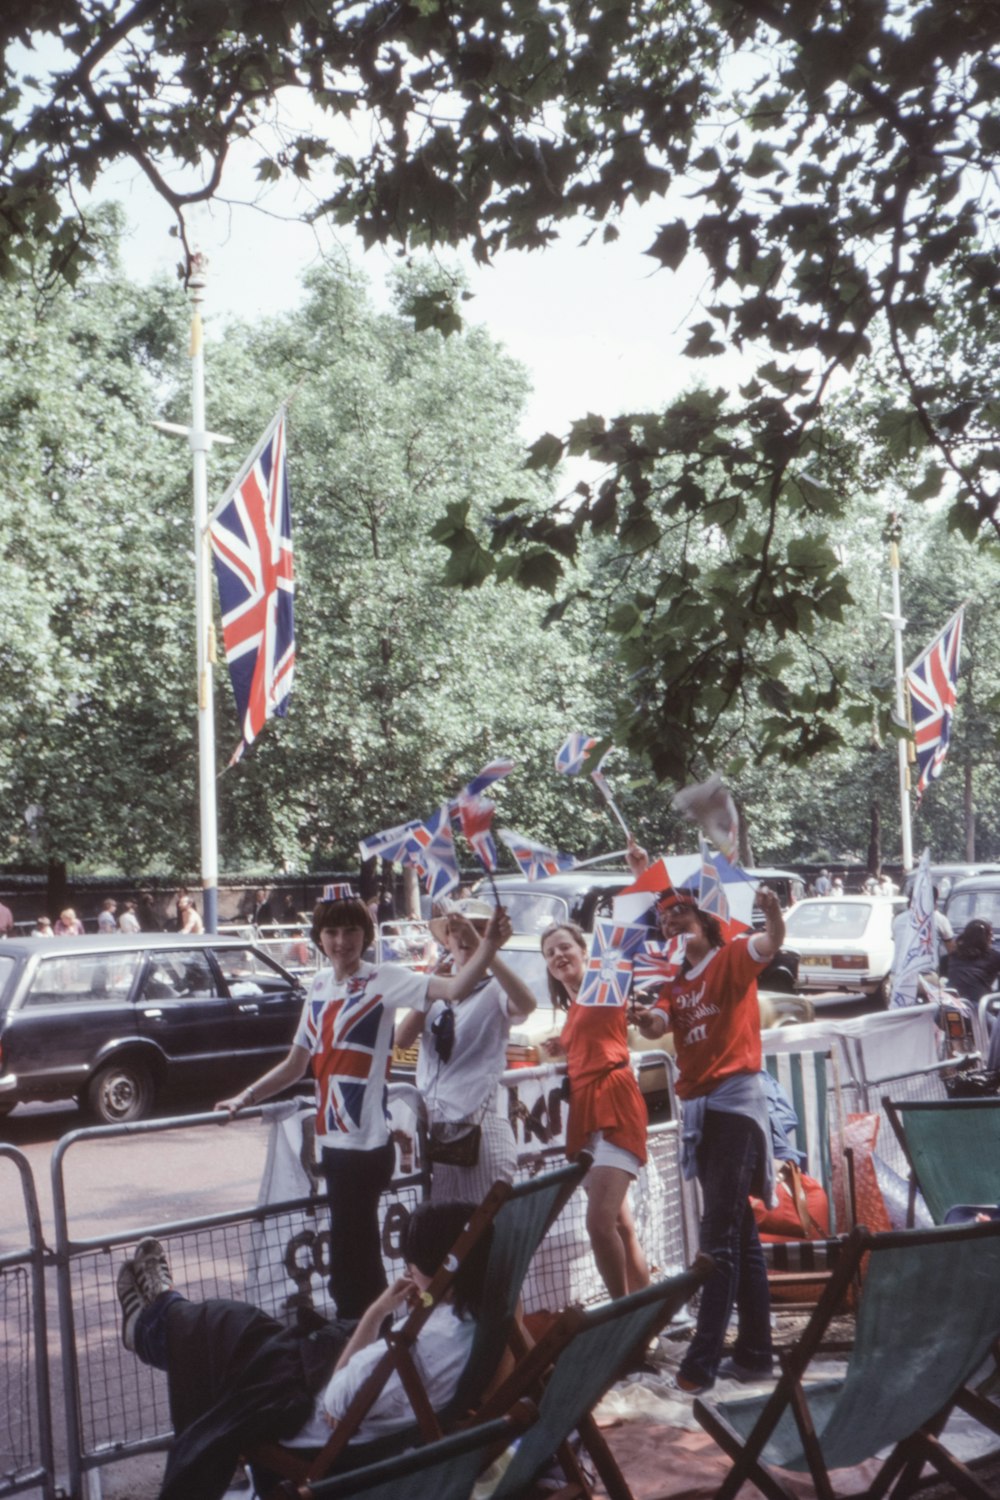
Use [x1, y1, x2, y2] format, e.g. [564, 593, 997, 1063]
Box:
[247, 1158, 589, 1479]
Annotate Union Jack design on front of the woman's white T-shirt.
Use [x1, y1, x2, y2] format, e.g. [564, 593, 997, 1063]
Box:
[306, 974, 382, 1136]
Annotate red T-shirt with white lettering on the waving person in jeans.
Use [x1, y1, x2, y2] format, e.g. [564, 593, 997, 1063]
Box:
[657, 938, 766, 1100]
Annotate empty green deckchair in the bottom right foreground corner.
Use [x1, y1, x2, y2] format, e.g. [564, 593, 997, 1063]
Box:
[694, 1223, 1000, 1500]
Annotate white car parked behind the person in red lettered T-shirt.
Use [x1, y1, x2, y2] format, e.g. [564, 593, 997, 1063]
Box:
[784, 896, 906, 1005]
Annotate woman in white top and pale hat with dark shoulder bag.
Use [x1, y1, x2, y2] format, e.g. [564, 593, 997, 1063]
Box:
[396, 900, 537, 1203]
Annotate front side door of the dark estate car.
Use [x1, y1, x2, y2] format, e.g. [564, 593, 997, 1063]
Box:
[214, 942, 306, 1079]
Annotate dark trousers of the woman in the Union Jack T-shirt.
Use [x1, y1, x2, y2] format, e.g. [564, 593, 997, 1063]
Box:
[321, 1140, 396, 1319]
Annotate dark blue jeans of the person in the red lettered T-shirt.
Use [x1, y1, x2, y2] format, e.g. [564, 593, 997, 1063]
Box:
[681, 1109, 772, 1386]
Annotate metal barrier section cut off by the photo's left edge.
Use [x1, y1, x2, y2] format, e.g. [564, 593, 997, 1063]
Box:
[0, 1145, 55, 1500]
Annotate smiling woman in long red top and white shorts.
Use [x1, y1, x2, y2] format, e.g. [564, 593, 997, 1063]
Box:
[541, 923, 649, 1298]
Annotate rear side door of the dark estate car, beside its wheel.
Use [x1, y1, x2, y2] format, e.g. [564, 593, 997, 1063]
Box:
[135, 942, 246, 1092]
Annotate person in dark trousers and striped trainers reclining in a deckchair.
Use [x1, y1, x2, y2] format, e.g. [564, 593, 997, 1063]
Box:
[117, 1203, 490, 1500]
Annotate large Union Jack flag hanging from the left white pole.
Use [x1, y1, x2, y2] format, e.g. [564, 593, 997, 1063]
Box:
[208, 408, 295, 765]
